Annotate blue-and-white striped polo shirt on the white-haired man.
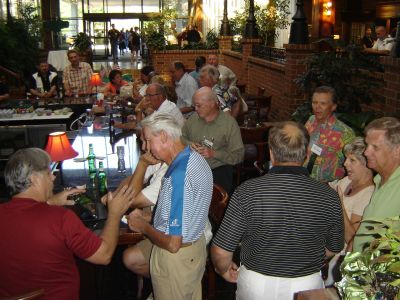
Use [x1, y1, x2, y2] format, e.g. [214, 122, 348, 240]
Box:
[153, 147, 213, 243]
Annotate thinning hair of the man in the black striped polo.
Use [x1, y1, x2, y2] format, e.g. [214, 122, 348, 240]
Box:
[268, 121, 310, 163]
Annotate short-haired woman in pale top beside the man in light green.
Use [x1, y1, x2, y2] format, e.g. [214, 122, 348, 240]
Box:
[325, 137, 375, 286]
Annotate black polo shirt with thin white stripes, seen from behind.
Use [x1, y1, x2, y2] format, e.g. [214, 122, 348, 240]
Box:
[214, 166, 344, 278]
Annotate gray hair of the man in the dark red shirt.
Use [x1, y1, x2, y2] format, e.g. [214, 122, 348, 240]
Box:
[4, 148, 51, 195]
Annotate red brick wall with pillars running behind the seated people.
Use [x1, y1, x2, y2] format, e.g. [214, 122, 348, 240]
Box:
[152, 37, 400, 121]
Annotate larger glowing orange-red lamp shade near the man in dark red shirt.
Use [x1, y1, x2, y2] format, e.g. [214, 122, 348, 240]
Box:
[44, 132, 78, 161]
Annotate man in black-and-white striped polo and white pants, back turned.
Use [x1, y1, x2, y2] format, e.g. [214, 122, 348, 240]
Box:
[211, 122, 344, 300]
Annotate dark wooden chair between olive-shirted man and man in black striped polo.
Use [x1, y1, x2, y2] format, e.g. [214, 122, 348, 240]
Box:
[236, 127, 269, 185]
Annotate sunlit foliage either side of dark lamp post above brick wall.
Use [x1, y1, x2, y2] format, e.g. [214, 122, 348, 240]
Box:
[230, 0, 290, 46]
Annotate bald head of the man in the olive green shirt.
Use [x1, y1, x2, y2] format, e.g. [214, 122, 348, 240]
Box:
[193, 87, 219, 122]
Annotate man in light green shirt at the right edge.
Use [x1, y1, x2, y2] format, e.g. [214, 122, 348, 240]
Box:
[353, 117, 400, 251]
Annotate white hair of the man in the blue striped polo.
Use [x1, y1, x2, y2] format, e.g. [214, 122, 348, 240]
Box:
[141, 112, 182, 140]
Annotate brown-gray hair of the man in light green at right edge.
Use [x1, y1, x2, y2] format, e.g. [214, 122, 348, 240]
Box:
[364, 117, 400, 147]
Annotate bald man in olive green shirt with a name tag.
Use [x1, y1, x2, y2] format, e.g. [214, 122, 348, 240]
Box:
[182, 87, 244, 193]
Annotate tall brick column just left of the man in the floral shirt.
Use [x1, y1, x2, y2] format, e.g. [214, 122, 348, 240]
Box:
[273, 44, 315, 120]
